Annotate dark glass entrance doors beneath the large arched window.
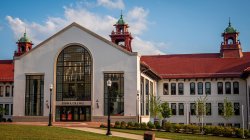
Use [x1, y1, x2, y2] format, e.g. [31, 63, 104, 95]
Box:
[56, 106, 91, 121]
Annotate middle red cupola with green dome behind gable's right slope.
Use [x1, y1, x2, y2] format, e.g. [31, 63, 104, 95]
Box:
[110, 13, 133, 52]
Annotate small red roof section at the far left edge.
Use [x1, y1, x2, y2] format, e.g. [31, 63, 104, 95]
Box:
[0, 60, 14, 82]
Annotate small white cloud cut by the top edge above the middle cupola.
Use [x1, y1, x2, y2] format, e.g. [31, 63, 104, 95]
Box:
[97, 0, 125, 9]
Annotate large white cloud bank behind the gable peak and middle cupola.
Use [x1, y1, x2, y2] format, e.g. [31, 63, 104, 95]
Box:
[6, 1, 166, 54]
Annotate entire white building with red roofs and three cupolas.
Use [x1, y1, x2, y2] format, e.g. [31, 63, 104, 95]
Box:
[0, 15, 250, 127]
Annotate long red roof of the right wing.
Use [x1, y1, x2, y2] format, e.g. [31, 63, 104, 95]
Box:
[141, 52, 250, 79]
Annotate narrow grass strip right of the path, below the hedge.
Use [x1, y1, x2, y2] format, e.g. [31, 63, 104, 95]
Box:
[111, 129, 239, 140]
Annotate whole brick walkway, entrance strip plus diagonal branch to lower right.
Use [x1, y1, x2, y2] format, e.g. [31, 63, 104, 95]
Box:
[9, 122, 170, 140]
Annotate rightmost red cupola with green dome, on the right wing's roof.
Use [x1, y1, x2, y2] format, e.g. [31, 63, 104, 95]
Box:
[220, 19, 243, 58]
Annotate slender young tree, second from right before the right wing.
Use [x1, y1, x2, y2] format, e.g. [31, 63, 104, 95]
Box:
[195, 96, 208, 133]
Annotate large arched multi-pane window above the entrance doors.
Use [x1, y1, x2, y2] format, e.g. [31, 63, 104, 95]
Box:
[56, 45, 92, 101]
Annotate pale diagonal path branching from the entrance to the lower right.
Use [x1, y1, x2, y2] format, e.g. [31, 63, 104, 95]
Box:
[64, 127, 167, 140]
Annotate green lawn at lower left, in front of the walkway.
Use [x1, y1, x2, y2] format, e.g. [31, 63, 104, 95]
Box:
[0, 124, 129, 140]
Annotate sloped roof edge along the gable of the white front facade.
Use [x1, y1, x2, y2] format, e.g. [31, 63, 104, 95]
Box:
[14, 22, 138, 59]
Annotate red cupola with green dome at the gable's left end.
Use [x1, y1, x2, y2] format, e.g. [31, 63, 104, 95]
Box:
[14, 31, 33, 57]
